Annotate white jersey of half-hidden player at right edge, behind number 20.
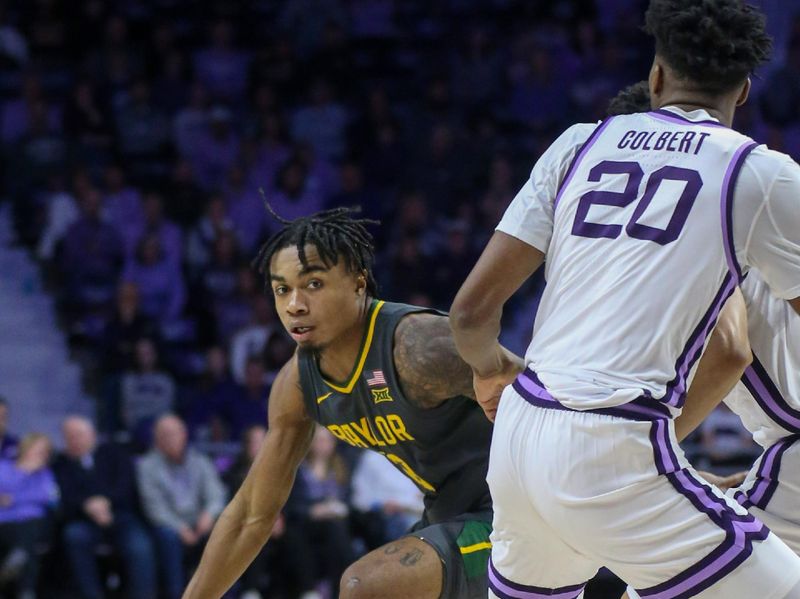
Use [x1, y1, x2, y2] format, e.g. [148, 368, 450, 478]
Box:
[725, 270, 800, 448]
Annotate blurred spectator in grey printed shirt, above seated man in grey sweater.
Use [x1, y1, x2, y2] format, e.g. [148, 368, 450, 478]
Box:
[122, 339, 175, 441]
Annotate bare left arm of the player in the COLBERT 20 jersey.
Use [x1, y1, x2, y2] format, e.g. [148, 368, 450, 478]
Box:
[450, 231, 544, 410]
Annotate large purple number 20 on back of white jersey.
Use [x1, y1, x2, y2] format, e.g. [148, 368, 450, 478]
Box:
[572, 160, 703, 245]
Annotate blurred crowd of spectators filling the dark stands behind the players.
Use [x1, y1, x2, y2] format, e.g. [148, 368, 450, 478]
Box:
[0, 0, 800, 599]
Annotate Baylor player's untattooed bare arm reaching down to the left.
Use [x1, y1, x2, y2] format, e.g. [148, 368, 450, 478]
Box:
[183, 357, 314, 599]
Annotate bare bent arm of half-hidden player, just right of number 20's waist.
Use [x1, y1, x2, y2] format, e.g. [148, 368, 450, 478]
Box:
[675, 288, 753, 441]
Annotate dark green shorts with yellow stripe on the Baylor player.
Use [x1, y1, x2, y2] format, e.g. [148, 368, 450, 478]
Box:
[408, 512, 492, 599]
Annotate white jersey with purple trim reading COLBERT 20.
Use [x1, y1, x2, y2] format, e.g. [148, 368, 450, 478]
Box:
[498, 108, 800, 412]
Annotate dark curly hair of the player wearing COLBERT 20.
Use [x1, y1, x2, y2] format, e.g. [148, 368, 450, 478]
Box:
[644, 0, 772, 93]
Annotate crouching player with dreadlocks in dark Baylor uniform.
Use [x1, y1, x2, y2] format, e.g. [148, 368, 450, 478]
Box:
[184, 208, 522, 599]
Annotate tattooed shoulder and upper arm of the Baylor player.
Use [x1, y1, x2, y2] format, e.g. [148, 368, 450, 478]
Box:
[394, 313, 475, 408]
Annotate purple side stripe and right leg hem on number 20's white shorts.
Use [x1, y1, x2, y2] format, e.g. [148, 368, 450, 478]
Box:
[637, 440, 769, 599]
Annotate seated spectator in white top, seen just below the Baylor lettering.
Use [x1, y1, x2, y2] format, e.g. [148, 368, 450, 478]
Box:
[351, 451, 425, 551]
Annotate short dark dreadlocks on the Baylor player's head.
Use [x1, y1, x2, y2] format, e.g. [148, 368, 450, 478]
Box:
[253, 204, 380, 297]
